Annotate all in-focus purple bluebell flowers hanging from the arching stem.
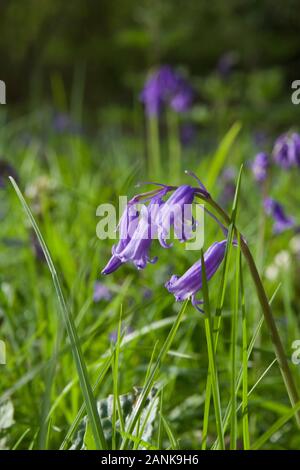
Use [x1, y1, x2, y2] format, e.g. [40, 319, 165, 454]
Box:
[102, 183, 227, 311]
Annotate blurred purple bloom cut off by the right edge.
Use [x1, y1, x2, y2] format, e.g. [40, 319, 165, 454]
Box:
[273, 132, 300, 170]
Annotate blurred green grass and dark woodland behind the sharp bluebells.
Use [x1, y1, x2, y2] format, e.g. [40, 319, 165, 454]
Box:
[0, 0, 300, 449]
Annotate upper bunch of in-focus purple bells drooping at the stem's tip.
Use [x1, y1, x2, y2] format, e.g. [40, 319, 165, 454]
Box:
[102, 179, 208, 274]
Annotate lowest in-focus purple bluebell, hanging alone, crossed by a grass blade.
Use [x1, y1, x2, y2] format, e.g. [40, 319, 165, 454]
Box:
[165, 240, 227, 311]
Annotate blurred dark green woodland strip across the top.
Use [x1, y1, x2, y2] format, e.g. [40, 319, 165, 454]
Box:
[0, 0, 300, 108]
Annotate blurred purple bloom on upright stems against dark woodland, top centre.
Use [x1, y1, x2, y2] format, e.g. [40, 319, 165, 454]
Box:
[141, 65, 194, 116]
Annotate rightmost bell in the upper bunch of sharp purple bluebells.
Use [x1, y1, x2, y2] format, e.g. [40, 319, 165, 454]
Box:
[157, 185, 198, 248]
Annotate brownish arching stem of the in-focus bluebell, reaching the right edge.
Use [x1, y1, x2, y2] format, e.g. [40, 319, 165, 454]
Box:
[198, 195, 300, 427]
